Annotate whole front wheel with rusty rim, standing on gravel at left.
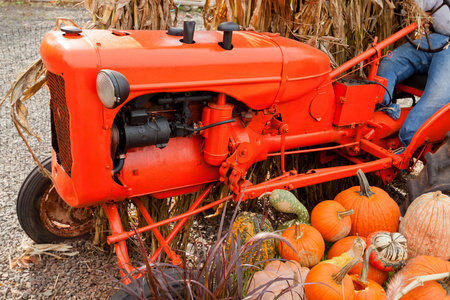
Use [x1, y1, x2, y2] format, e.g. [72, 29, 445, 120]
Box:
[17, 158, 92, 244]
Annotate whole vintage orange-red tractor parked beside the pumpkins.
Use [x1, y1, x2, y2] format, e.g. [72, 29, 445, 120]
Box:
[18, 5, 450, 282]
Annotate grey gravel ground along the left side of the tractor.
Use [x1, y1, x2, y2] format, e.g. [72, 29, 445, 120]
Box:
[0, 2, 204, 299]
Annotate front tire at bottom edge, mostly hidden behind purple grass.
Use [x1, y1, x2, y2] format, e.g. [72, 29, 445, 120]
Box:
[109, 268, 187, 300]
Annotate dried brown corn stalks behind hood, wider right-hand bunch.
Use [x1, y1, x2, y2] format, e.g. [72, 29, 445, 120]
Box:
[203, 0, 397, 64]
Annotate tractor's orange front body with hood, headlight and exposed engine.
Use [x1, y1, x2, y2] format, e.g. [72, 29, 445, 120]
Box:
[41, 23, 336, 207]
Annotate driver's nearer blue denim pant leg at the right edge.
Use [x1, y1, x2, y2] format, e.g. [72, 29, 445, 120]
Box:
[399, 44, 450, 146]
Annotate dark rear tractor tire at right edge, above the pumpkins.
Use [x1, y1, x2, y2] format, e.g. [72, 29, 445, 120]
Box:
[407, 131, 450, 202]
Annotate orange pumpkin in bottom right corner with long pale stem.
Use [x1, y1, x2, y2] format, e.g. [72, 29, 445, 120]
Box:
[387, 255, 450, 300]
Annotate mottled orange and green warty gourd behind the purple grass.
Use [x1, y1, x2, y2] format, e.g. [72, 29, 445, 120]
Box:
[227, 212, 276, 264]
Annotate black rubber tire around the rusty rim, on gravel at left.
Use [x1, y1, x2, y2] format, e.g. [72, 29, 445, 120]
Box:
[16, 158, 91, 244]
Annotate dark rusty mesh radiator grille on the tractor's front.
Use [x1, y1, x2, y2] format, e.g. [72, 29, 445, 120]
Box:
[47, 72, 72, 176]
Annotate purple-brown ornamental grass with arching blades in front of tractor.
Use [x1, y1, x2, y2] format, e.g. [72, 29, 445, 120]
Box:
[107, 191, 295, 300]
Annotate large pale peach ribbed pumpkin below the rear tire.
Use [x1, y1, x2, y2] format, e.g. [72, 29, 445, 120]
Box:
[399, 191, 450, 260]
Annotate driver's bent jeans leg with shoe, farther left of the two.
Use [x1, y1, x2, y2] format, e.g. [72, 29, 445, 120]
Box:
[377, 39, 432, 120]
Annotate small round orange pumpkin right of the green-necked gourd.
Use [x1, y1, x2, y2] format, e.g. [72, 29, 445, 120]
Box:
[311, 200, 353, 242]
